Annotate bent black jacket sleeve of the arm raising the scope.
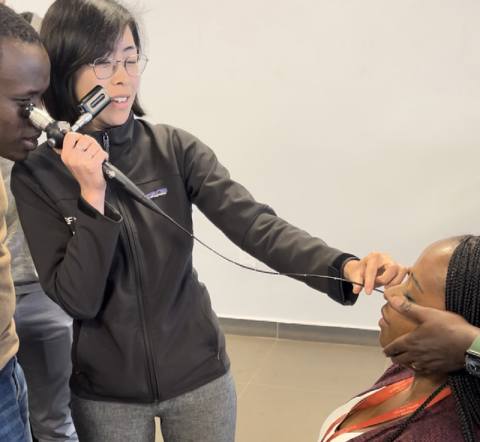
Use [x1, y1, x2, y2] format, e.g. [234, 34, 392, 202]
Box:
[11, 163, 121, 319]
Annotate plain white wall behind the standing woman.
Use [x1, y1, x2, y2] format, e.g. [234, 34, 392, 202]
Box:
[8, 0, 480, 328]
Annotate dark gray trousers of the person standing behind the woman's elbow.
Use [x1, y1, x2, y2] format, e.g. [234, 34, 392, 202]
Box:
[14, 290, 78, 442]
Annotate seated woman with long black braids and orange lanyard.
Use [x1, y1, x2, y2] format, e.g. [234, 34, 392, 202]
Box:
[319, 236, 480, 442]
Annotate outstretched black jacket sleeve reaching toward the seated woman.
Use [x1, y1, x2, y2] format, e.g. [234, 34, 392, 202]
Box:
[173, 130, 358, 305]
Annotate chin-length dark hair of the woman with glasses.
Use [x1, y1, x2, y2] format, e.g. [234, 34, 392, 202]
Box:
[40, 0, 145, 123]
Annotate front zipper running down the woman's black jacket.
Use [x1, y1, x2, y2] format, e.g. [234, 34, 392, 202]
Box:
[103, 132, 160, 402]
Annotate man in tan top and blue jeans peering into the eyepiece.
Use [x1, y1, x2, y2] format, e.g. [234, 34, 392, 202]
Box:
[0, 0, 102, 442]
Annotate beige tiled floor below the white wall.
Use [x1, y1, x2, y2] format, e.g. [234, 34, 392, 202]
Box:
[157, 335, 388, 442]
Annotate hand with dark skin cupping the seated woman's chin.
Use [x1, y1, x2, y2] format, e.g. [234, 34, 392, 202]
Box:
[383, 295, 480, 374]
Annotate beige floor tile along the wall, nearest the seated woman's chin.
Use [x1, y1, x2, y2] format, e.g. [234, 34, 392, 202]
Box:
[252, 340, 385, 395]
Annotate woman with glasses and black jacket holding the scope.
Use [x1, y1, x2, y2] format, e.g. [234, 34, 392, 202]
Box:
[12, 0, 405, 442]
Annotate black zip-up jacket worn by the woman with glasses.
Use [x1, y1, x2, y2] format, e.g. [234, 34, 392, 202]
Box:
[12, 116, 357, 403]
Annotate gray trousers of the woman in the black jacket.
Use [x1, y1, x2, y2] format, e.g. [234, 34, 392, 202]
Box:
[71, 372, 237, 442]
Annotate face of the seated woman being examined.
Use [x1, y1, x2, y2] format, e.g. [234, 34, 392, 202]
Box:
[379, 238, 457, 347]
